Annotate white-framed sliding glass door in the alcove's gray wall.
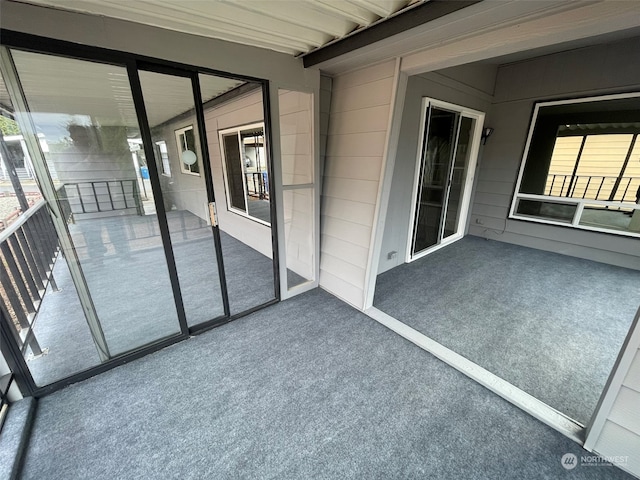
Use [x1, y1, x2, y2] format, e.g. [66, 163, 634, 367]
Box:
[407, 99, 484, 261]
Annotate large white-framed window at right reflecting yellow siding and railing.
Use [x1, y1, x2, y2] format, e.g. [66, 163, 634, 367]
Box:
[510, 93, 640, 236]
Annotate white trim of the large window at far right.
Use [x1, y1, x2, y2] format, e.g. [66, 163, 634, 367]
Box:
[509, 92, 640, 238]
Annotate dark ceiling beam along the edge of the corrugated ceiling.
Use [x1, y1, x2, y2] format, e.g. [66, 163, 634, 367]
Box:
[302, 0, 482, 68]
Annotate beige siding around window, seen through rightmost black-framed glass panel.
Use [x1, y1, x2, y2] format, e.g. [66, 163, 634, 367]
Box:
[204, 89, 272, 258]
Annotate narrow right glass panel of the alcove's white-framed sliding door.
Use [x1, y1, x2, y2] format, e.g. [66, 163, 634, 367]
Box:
[442, 116, 475, 239]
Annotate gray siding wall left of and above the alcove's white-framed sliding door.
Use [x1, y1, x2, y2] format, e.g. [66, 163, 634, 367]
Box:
[378, 65, 496, 273]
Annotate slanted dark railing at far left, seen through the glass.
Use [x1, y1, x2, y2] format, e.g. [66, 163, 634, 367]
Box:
[0, 200, 58, 355]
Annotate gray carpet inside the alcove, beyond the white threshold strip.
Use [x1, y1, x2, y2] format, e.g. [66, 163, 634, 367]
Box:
[374, 236, 640, 424]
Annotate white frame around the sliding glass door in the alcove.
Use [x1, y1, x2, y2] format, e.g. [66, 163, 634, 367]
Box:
[405, 97, 485, 263]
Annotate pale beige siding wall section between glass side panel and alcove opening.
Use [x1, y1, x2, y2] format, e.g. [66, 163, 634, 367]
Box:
[320, 61, 395, 308]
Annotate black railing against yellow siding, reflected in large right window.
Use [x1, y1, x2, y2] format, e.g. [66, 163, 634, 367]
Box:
[544, 174, 640, 203]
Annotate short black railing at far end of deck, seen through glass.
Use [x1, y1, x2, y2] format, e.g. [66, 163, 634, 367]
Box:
[64, 179, 143, 215]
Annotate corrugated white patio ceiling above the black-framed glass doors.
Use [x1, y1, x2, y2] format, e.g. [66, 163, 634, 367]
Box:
[14, 0, 420, 55]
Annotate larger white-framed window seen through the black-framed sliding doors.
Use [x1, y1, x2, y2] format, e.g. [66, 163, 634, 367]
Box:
[219, 123, 271, 225]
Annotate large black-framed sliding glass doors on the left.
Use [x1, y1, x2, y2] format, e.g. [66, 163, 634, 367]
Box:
[0, 40, 279, 391]
